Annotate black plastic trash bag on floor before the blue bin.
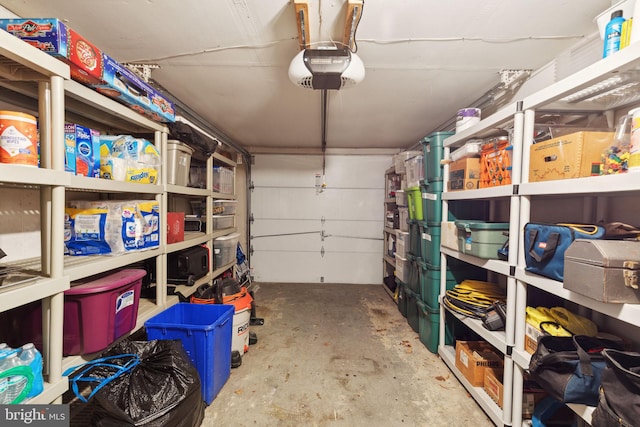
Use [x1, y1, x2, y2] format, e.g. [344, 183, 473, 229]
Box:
[90, 340, 206, 427]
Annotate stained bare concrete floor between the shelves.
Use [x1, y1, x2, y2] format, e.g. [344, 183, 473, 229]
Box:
[202, 283, 493, 427]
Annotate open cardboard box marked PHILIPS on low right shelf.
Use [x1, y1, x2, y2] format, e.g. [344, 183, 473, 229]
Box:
[456, 341, 502, 387]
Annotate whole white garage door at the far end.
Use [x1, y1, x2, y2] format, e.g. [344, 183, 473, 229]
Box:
[250, 154, 391, 284]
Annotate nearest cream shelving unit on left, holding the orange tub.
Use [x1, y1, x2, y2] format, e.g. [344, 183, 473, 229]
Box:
[0, 27, 70, 403]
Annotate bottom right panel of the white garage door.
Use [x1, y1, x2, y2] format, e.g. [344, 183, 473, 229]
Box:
[324, 252, 382, 284]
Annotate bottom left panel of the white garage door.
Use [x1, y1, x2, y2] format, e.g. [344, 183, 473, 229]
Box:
[251, 251, 322, 283]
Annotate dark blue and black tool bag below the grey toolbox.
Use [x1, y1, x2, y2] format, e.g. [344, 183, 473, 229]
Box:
[529, 335, 621, 406]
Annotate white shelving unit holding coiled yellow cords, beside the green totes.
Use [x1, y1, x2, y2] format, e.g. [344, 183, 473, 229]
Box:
[438, 103, 523, 425]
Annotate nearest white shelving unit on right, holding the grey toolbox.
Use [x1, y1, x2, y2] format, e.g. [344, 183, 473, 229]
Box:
[513, 43, 640, 425]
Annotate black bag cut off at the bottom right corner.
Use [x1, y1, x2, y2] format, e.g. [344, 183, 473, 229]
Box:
[591, 349, 640, 427]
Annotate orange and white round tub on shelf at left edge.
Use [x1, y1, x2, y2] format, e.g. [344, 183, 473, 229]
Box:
[0, 111, 38, 166]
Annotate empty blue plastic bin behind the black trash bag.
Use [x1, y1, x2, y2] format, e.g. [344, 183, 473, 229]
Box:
[144, 303, 234, 405]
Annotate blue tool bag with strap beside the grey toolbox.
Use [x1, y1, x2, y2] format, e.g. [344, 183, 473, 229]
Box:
[524, 222, 605, 281]
